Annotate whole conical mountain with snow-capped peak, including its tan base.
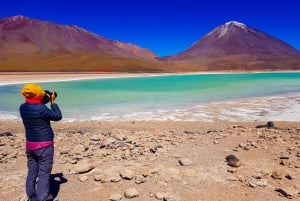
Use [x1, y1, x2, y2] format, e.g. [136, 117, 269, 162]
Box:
[162, 21, 300, 70]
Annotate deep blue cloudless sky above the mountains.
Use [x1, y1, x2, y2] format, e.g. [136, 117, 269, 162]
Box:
[0, 0, 300, 56]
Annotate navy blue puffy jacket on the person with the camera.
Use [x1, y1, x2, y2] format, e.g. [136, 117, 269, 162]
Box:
[20, 103, 62, 142]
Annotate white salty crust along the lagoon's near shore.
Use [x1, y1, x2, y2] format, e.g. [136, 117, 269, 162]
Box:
[0, 94, 300, 122]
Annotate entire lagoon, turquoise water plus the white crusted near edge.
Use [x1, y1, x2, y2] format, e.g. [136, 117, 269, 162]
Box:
[0, 72, 300, 121]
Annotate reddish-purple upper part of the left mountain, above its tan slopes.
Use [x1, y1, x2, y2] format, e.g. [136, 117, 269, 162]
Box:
[0, 15, 156, 58]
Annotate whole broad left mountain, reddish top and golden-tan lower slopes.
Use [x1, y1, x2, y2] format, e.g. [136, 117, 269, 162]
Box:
[0, 16, 166, 71]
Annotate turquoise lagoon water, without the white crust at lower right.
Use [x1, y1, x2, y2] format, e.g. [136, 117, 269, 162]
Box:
[0, 72, 300, 120]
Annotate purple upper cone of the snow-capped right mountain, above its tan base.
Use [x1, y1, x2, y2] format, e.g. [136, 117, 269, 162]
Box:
[166, 21, 300, 59]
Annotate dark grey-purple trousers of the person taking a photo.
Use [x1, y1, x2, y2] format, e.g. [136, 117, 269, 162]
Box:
[26, 145, 54, 201]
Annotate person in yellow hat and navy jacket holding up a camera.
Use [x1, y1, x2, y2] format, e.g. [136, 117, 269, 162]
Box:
[20, 83, 62, 201]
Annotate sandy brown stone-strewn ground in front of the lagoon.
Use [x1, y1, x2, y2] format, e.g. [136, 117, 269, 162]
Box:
[0, 121, 300, 201]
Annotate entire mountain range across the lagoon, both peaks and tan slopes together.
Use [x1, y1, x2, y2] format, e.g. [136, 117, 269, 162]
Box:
[0, 15, 300, 72]
